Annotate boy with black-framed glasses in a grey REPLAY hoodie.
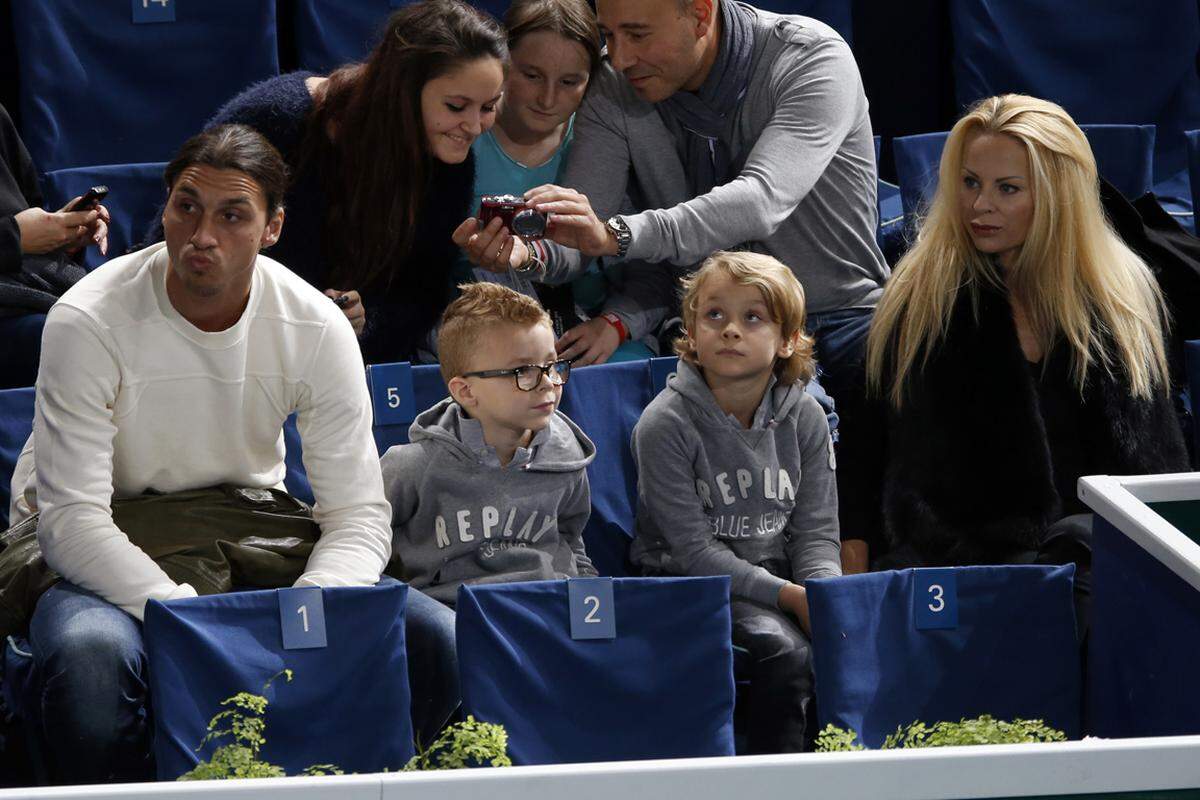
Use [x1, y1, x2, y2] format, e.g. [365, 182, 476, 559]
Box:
[383, 283, 596, 606]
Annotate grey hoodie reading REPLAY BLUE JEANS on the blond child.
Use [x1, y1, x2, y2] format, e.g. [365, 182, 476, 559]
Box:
[630, 361, 841, 607]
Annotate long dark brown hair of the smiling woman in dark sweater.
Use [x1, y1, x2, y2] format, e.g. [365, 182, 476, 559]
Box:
[301, 0, 508, 288]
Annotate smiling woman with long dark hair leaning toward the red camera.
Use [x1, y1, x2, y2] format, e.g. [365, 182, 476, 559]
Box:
[200, 0, 509, 363]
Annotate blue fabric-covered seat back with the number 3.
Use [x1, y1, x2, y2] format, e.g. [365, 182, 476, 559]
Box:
[806, 565, 1081, 747]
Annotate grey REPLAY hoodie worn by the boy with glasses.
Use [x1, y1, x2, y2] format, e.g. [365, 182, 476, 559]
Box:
[382, 397, 596, 606]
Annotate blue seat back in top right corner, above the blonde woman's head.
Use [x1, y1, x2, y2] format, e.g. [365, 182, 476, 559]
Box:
[949, 0, 1200, 184]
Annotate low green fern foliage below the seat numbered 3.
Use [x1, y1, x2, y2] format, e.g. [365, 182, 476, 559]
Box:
[816, 714, 1067, 752]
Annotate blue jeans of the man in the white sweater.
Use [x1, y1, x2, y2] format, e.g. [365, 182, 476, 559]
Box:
[29, 578, 460, 783]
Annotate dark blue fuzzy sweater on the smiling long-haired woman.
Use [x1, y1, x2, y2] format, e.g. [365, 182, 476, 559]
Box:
[209, 72, 475, 363]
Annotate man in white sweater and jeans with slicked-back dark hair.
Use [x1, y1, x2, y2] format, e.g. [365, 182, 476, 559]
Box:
[12, 126, 391, 782]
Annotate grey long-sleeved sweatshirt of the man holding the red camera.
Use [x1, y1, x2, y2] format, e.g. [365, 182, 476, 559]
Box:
[550, 4, 888, 337]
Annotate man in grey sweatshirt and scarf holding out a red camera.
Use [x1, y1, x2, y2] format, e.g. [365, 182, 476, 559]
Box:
[467, 0, 889, 566]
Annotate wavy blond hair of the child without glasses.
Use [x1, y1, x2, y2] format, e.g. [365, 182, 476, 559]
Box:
[674, 251, 816, 383]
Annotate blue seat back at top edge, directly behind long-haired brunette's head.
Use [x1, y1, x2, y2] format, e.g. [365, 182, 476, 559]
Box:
[295, 0, 509, 73]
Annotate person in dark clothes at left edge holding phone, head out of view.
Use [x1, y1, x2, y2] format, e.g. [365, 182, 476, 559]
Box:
[0, 106, 109, 389]
